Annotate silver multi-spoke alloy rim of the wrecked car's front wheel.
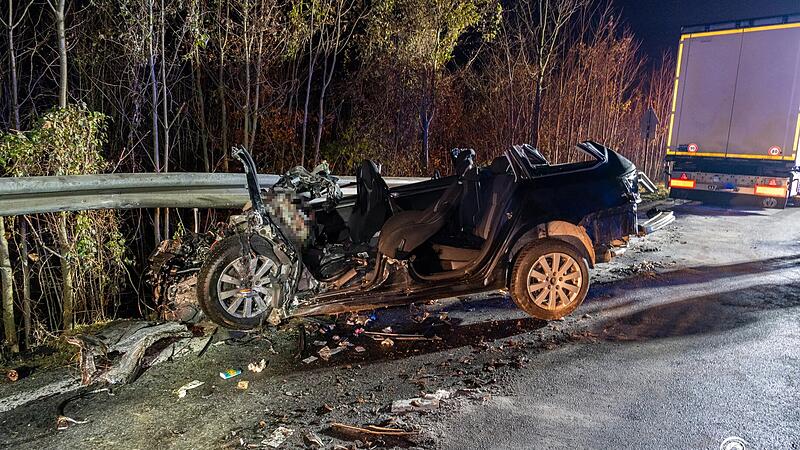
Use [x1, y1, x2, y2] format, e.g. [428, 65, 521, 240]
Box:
[217, 256, 276, 319]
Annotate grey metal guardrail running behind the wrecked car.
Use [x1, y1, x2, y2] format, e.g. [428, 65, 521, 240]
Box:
[0, 172, 428, 216]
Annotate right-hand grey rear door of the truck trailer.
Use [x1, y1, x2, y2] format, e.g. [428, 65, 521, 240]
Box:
[727, 24, 800, 160]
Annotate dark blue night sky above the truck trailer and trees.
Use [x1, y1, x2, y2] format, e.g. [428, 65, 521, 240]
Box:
[614, 0, 800, 59]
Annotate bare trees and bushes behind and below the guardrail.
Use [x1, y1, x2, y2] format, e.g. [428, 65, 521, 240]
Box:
[0, 0, 674, 354]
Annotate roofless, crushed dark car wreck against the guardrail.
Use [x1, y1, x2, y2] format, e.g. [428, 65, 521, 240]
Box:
[196, 141, 638, 329]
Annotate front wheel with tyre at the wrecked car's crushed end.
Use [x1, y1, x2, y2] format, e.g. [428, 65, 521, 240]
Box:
[197, 235, 278, 330]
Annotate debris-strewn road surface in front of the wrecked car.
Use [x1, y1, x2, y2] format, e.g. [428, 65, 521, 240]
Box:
[0, 204, 800, 449]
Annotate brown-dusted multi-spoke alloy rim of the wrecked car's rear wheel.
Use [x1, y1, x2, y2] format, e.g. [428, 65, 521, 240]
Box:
[527, 252, 583, 311]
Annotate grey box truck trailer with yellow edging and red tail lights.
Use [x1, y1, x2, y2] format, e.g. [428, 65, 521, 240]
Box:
[666, 13, 800, 208]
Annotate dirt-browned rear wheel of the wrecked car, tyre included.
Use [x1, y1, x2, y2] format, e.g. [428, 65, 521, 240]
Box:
[510, 239, 589, 320]
